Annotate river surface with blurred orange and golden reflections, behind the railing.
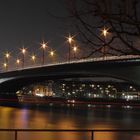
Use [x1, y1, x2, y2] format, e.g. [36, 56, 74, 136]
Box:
[0, 107, 140, 140]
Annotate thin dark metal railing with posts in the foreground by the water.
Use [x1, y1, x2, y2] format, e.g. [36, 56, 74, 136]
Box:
[0, 129, 140, 140]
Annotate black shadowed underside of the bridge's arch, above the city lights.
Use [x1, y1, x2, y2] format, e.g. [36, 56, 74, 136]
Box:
[0, 74, 137, 93]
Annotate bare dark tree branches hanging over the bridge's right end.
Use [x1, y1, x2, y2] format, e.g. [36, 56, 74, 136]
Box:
[66, 0, 140, 57]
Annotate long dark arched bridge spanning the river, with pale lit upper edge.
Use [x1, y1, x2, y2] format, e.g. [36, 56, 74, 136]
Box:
[0, 55, 140, 92]
